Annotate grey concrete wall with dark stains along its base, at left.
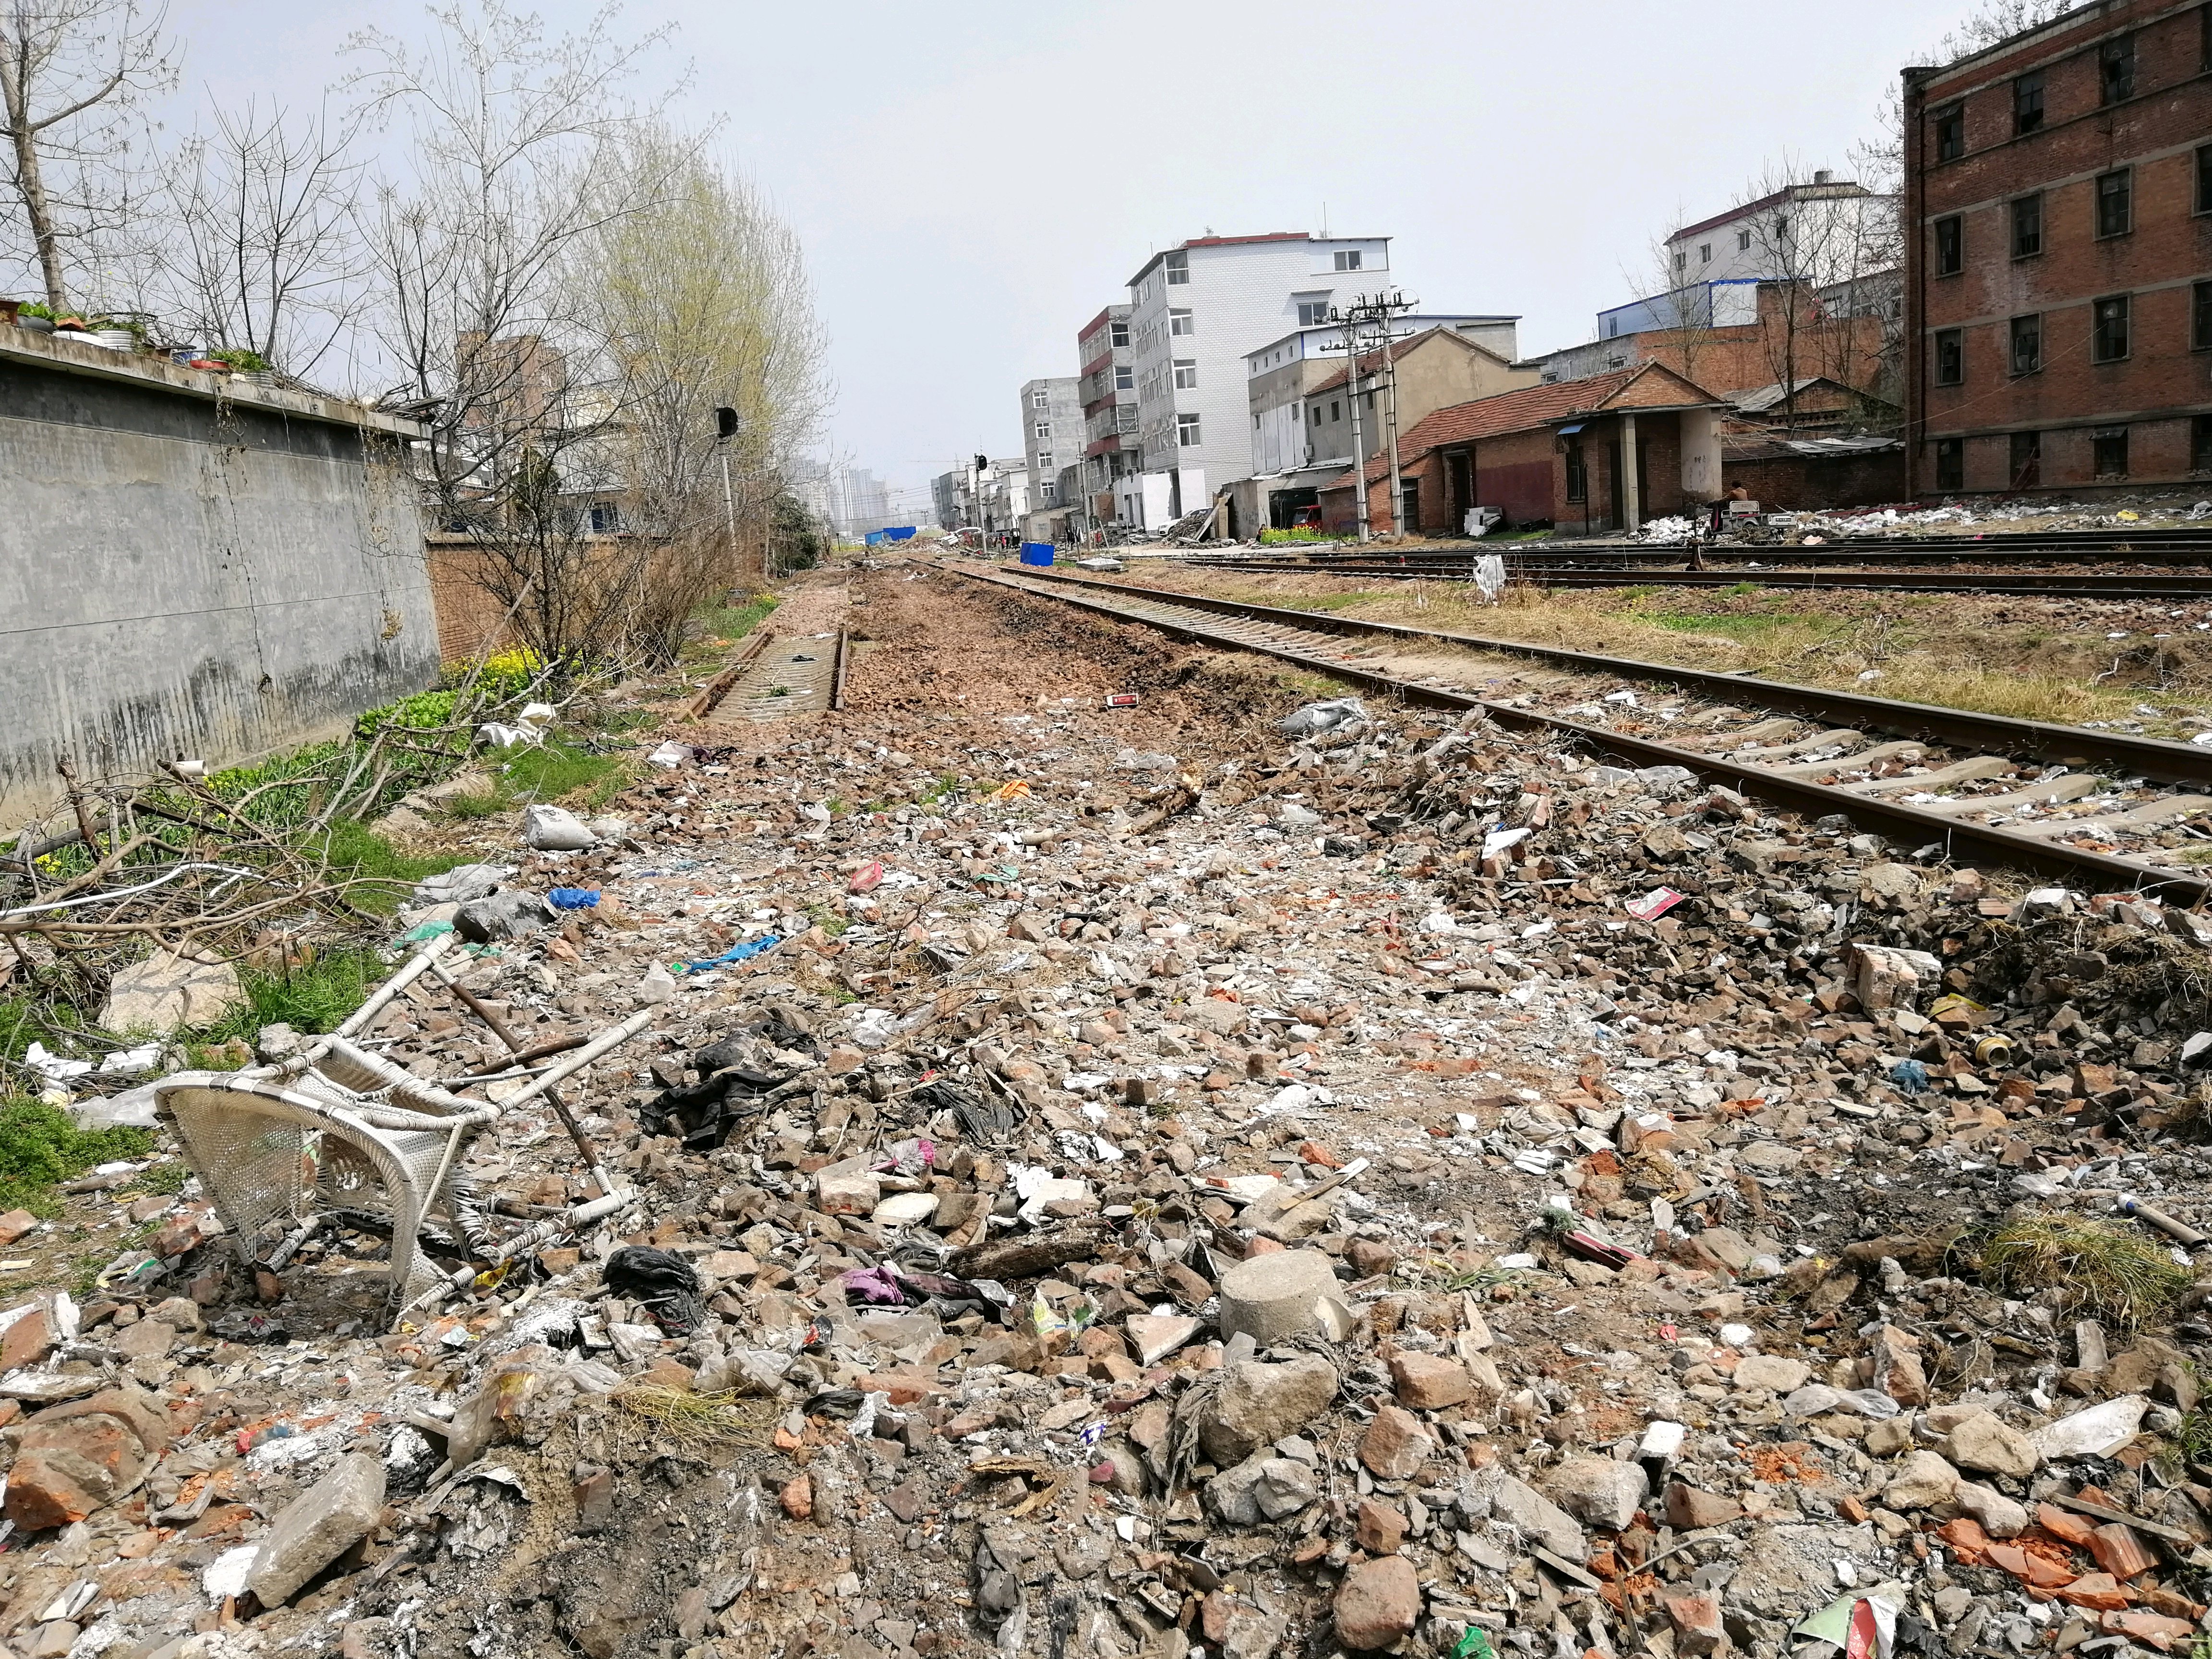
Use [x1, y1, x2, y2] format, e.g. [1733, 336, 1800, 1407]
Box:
[0, 330, 438, 827]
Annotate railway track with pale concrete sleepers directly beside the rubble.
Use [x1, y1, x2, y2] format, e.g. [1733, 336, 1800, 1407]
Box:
[934, 560, 2212, 902]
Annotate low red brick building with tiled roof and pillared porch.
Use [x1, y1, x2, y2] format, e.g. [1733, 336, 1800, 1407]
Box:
[1321, 363, 1728, 535]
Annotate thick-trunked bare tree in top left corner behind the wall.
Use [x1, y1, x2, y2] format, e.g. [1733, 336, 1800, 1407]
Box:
[0, 0, 175, 312]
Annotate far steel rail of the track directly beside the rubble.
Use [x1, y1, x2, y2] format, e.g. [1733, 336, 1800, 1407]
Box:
[991, 559, 2212, 785]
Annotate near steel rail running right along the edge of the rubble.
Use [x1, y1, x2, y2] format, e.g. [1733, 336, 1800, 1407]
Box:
[934, 560, 2212, 905]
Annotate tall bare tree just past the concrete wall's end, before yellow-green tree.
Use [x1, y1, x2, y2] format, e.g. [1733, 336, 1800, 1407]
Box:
[345, 0, 666, 677]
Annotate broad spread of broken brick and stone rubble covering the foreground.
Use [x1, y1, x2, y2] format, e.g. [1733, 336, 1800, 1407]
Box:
[13, 566, 2212, 1659]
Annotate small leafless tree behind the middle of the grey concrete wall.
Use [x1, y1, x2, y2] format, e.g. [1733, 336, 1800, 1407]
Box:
[164, 99, 370, 378]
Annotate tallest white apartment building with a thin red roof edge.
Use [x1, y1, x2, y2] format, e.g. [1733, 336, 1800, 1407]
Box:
[1115, 230, 1391, 529]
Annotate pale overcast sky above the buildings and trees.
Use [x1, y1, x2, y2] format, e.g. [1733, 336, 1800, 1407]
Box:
[151, 0, 1967, 506]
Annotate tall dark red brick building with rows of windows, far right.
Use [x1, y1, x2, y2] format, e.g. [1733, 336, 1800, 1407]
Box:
[1904, 0, 2212, 495]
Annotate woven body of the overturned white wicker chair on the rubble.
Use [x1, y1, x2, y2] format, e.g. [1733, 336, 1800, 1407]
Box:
[155, 1037, 498, 1312]
